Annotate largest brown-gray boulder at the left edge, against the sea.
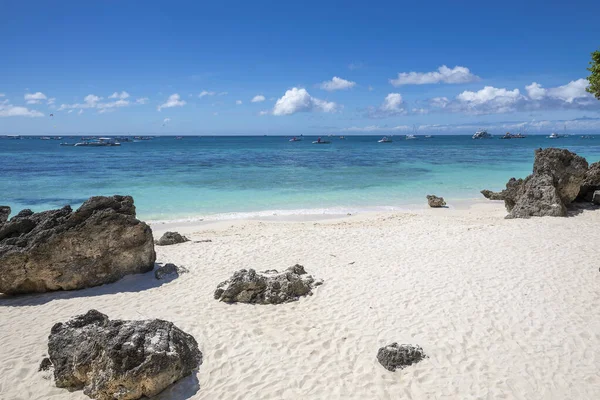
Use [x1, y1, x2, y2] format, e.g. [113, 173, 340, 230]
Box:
[0, 196, 156, 294]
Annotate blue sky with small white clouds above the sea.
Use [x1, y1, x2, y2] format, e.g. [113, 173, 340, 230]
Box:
[0, 1, 600, 135]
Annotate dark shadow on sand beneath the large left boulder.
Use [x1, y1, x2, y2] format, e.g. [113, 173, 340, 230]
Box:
[0, 263, 176, 307]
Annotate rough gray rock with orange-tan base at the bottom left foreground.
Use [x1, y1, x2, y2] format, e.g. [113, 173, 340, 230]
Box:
[48, 310, 202, 400]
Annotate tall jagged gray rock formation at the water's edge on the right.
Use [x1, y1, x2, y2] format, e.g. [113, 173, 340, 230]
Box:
[481, 148, 588, 218]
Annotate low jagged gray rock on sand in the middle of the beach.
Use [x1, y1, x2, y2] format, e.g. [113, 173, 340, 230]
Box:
[215, 264, 323, 304]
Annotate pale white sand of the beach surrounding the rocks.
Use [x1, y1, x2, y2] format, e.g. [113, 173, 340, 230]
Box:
[0, 203, 600, 400]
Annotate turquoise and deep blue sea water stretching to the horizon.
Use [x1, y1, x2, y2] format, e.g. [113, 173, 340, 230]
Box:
[0, 136, 600, 220]
